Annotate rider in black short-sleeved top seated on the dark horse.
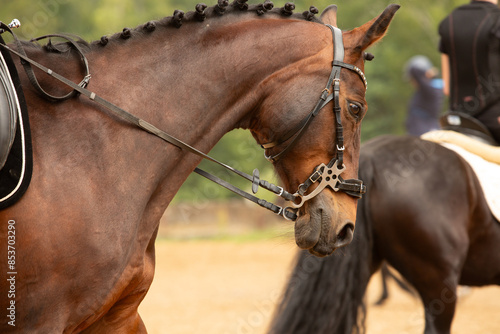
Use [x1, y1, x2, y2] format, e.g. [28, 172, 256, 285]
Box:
[439, 0, 500, 142]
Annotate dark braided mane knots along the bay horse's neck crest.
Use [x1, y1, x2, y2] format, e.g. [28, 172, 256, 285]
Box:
[23, 0, 321, 53]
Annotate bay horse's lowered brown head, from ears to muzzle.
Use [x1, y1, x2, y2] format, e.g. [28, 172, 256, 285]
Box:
[251, 5, 399, 256]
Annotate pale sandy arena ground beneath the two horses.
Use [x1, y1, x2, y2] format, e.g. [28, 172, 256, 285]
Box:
[140, 238, 500, 334]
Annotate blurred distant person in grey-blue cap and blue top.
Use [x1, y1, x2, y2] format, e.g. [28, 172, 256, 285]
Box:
[405, 55, 444, 136]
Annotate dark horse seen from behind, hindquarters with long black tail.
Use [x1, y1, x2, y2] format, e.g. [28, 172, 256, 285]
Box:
[270, 136, 500, 334]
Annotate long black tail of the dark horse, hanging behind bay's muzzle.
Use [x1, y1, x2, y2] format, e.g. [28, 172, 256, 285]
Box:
[269, 157, 374, 334]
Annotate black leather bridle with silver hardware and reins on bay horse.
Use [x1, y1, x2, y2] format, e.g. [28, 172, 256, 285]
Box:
[0, 22, 367, 220]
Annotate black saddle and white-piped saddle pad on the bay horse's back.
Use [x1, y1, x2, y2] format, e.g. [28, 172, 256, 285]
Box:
[0, 36, 33, 210]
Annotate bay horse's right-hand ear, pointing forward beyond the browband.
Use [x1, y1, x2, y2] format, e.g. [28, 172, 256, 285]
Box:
[355, 4, 401, 50]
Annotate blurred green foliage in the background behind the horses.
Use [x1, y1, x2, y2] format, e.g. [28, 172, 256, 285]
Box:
[0, 0, 467, 201]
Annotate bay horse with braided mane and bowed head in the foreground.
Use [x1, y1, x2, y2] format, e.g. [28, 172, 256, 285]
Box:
[0, 0, 399, 333]
